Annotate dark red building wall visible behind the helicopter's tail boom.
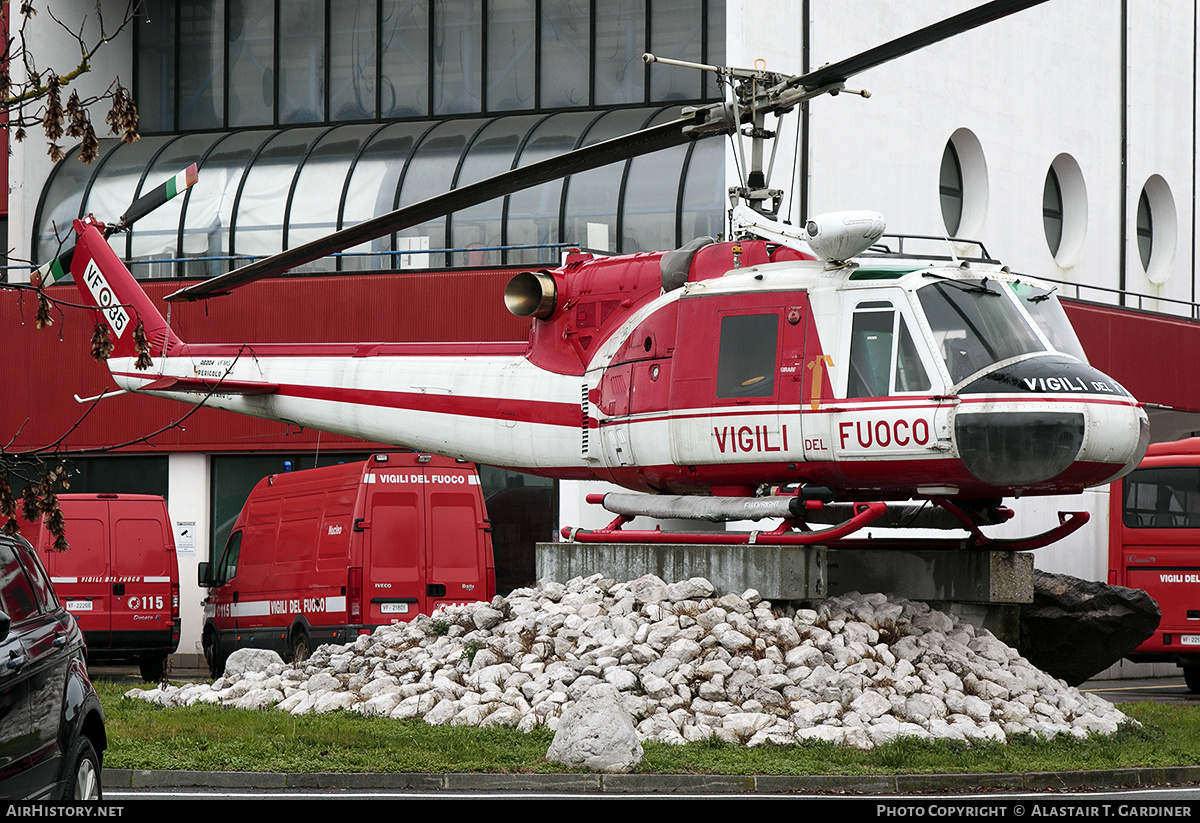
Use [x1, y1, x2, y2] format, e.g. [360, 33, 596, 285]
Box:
[0, 270, 529, 451]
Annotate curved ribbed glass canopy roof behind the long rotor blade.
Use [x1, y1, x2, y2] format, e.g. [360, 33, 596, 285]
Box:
[34, 108, 726, 277]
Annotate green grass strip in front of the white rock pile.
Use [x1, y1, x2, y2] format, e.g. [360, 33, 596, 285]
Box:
[96, 680, 1200, 775]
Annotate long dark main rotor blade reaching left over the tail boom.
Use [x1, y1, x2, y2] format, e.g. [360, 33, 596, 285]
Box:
[164, 115, 722, 302]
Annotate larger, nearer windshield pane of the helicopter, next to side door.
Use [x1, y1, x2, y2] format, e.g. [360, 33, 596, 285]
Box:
[917, 274, 1046, 384]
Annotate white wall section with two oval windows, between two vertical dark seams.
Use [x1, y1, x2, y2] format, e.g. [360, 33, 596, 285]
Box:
[810, 0, 1121, 288]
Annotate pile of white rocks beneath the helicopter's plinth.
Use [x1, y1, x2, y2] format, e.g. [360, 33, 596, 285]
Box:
[127, 575, 1133, 749]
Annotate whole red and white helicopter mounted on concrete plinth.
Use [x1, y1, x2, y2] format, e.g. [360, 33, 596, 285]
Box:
[42, 0, 1148, 548]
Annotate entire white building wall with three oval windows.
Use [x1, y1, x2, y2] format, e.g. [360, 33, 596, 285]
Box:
[727, 0, 1196, 321]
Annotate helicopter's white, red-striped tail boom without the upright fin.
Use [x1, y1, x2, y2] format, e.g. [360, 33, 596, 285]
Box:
[109, 343, 592, 476]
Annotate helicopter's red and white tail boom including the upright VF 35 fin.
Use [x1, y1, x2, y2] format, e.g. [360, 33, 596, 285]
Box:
[71, 221, 594, 477]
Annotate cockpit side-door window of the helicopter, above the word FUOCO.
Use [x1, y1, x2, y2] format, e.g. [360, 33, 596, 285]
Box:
[846, 301, 931, 397]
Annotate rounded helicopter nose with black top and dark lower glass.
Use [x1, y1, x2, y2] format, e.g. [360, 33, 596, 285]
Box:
[954, 358, 1150, 489]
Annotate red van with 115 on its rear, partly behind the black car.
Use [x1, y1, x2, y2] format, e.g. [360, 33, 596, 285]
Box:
[20, 494, 180, 681]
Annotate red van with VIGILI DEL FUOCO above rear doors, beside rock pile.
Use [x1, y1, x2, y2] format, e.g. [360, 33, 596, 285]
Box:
[199, 453, 496, 677]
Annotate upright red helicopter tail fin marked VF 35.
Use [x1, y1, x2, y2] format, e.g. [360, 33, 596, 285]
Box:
[71, 220, 182, 358]
